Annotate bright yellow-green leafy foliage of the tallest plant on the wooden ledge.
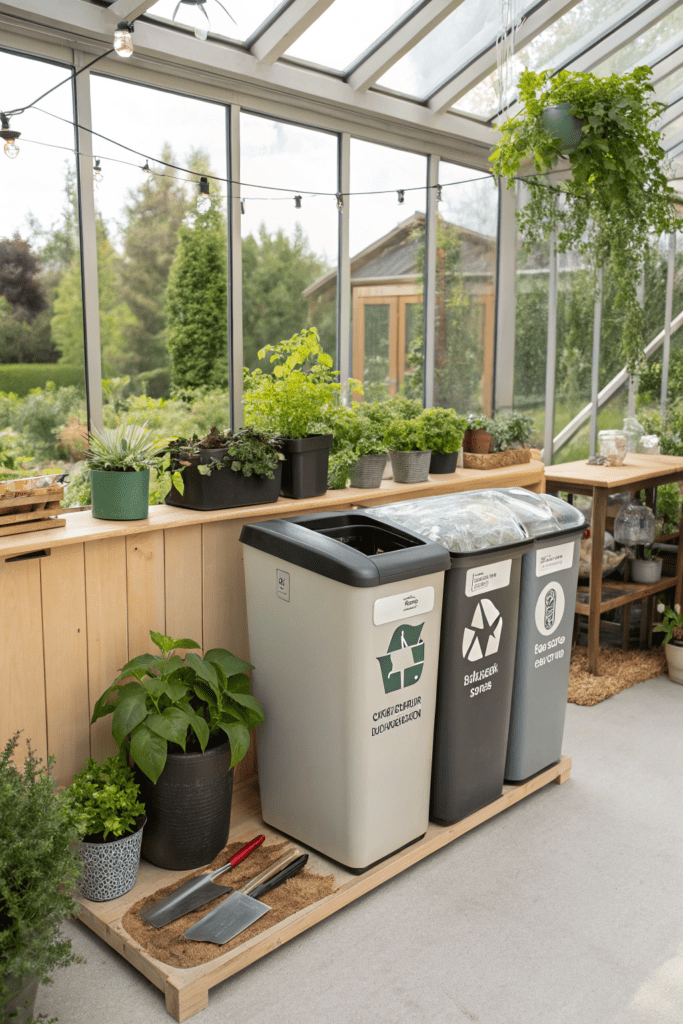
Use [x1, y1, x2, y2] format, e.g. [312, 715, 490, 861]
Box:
[244, 328, 362, 438]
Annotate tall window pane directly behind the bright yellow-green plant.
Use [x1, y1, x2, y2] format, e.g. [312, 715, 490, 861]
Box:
[240, 114, 339, 368]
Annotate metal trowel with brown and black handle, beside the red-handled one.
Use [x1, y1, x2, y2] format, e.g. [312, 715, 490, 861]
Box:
[183, 849, 308, 946]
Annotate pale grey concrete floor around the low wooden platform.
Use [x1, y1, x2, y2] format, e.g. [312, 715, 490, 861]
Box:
[37, 677, 683, 1024]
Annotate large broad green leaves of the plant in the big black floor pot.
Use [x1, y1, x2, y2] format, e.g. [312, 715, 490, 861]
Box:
[92, 630, 263, 782]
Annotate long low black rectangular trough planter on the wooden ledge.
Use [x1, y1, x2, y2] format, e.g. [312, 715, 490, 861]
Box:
[166, 449, 283, 512]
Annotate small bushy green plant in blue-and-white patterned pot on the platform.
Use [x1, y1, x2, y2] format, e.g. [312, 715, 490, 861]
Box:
[65, 754, 145, 902]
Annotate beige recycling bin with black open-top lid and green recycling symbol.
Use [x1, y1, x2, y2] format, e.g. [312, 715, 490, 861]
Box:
[241, 512, 451, 872]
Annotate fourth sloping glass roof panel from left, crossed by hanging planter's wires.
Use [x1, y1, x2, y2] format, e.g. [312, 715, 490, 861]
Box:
[453, 0, 643, 118]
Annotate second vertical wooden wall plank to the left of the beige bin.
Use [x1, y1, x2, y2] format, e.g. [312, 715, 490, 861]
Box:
[164, 525, 203, 654]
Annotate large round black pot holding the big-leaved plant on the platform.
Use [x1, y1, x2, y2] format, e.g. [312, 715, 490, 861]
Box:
[135, 740, 234, 871]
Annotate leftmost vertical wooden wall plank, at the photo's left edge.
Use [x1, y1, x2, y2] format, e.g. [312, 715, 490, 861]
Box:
[0, 556, 49, 764]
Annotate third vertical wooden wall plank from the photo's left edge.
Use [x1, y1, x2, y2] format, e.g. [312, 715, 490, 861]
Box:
[85, 537, 128, 761]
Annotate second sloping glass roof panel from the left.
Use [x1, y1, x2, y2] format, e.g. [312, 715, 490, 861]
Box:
[287, 0, 420, 72]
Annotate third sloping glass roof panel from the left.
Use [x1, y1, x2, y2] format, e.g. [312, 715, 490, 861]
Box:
[377, 0, 537, 99]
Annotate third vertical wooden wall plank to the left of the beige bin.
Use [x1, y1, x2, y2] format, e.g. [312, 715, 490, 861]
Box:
[126, 529, 166, 657]
